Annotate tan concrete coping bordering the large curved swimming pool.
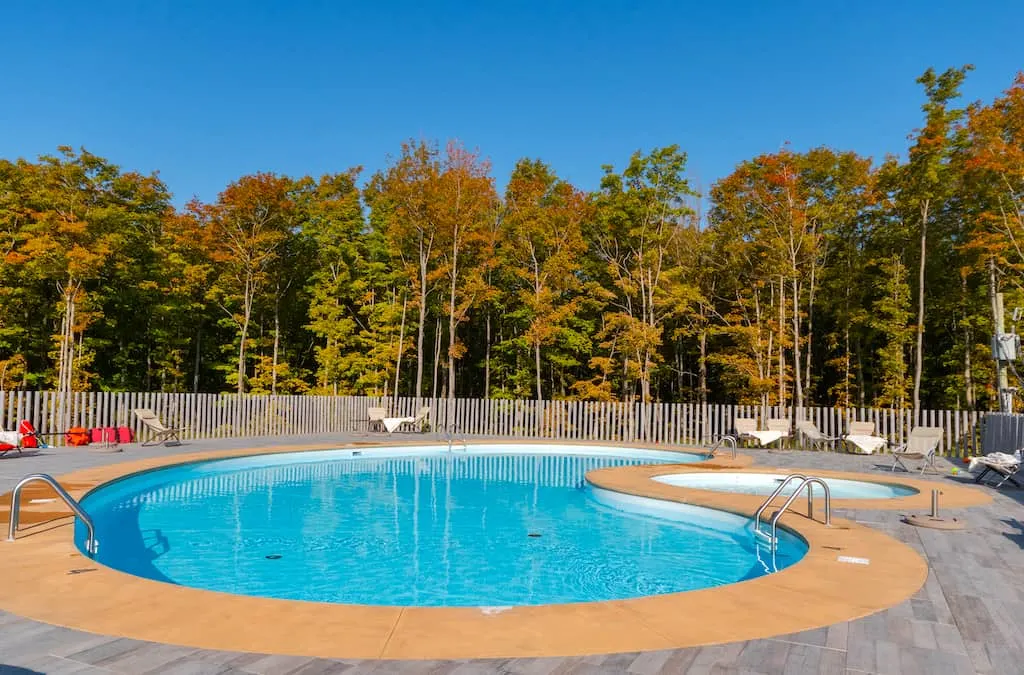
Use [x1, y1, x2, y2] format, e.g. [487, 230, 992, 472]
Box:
[0, 439, 928, 659]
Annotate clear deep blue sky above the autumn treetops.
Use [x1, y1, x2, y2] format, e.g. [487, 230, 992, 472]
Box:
[0, 0, 1024, 204]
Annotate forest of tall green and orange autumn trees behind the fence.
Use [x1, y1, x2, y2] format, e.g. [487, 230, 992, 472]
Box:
[0, 66, 1024, 410]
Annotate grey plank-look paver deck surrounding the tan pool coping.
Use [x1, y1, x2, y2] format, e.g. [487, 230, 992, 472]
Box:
[0, 433, 1024, 675]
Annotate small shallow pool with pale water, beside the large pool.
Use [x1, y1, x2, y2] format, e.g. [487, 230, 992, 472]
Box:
[653, 471, 919, 499]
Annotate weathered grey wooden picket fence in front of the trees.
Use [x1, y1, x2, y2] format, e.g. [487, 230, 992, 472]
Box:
[0, 391, 991, 454]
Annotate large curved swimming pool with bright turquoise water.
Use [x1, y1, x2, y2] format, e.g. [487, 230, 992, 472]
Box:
[76, 444, 807, 607]
